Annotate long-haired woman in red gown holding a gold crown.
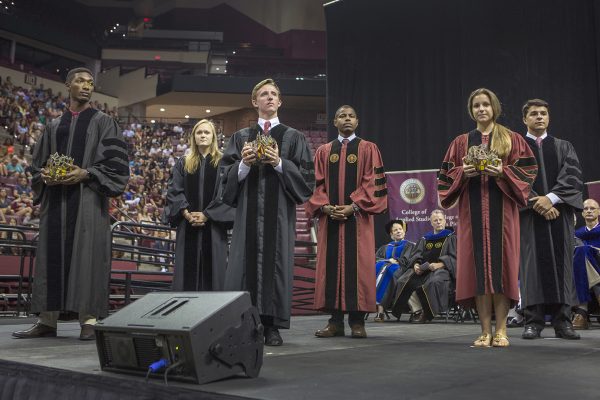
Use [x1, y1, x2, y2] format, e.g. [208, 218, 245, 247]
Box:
[438, 88, 537, 347]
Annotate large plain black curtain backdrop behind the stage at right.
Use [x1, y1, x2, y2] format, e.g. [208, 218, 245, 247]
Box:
[325, 0, 600, 181]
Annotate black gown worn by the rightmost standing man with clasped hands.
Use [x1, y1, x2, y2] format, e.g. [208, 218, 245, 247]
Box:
[520, 135, 583, 307]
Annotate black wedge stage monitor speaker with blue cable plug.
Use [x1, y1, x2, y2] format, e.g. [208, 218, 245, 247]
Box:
[95, 292, 264, 384]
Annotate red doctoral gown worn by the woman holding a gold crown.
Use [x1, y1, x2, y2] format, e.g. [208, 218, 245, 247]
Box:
[438, 130, 537, 307]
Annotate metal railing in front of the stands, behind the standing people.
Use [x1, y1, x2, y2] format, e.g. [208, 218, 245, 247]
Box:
[0, 216, 316, 315]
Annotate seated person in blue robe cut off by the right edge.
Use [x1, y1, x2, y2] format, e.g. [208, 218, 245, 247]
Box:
[573, 199, 600, 329]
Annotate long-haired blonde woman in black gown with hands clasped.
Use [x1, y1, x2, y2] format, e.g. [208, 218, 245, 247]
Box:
[165, 119, 235, 291]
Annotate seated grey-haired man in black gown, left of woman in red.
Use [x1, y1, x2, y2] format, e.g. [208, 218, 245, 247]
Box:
[392, 210, 456, 323]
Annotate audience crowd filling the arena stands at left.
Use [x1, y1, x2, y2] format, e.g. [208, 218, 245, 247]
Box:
[0, 77, 225, 234]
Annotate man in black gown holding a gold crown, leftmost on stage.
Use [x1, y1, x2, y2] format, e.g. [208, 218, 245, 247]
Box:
[13, 68, 129, 340]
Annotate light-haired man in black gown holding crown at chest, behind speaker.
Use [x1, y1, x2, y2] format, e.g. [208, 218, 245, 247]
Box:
[221, 79, 314, 346]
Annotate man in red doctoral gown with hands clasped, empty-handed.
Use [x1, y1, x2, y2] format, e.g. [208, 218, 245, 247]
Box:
[306, 105, 387, 338]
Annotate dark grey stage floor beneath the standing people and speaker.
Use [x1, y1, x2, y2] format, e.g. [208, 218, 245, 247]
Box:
[0, 316, 600, 400]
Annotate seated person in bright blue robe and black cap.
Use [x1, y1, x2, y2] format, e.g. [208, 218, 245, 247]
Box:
[375, 219, 415, 322]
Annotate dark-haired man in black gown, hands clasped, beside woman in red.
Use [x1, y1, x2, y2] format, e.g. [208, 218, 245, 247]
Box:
[520, 99, 583, 339]
